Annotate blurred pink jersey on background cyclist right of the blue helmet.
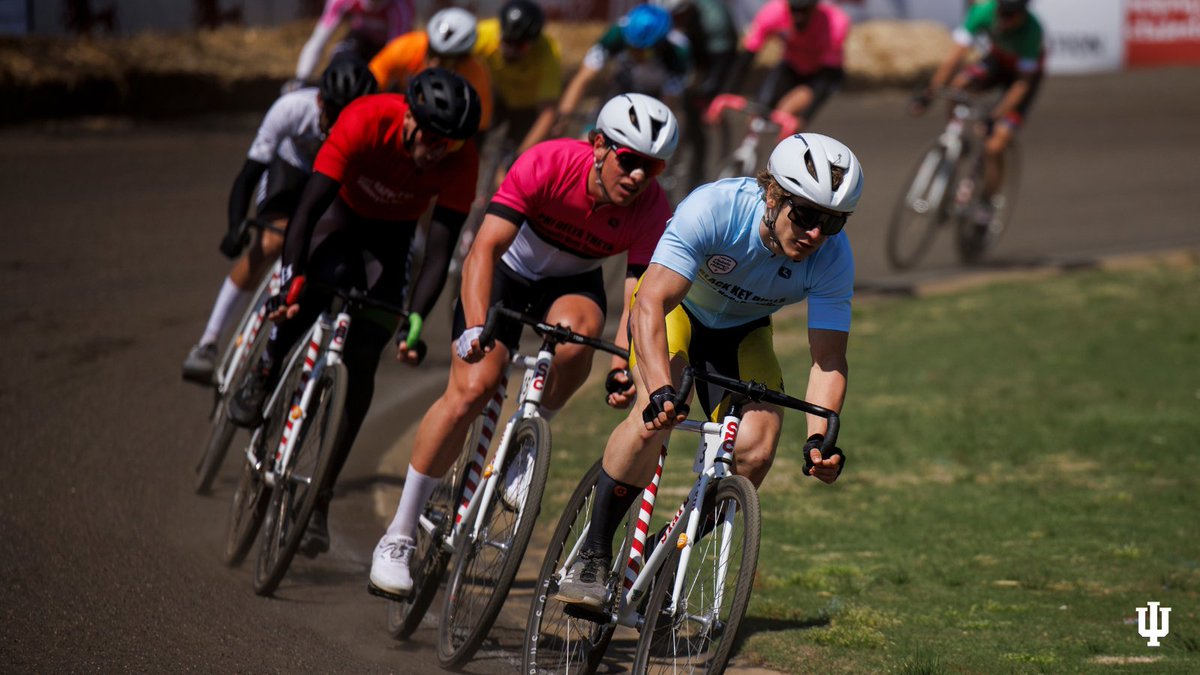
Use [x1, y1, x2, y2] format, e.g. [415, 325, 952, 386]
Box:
[745, 0, 851, 74]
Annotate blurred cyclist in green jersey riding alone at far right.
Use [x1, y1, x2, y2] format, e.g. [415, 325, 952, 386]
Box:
[908, 0, 1045, 226]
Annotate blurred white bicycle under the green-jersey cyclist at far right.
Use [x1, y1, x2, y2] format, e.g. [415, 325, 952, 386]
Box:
[887, 89, 1020, 270]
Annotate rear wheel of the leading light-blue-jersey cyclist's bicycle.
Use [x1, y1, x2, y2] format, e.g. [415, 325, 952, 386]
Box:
[521, 460, 624, 674]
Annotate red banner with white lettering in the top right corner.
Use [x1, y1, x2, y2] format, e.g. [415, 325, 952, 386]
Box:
[1126, 0, 1200, 66]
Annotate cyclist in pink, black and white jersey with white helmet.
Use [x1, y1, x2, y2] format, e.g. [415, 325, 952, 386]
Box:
[370, 94, 679, 596]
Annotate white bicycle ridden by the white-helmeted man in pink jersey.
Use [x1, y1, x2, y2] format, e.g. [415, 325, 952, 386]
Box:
[367, 306, 628, 668]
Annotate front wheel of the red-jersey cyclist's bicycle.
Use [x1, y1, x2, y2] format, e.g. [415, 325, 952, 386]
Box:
[254, 362, 347, 596]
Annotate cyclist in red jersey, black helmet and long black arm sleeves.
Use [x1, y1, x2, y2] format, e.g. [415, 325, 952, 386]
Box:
[229, 68, 480, 556]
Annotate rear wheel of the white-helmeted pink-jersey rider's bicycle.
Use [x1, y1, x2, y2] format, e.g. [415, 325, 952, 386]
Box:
[388, 418, 482, 640]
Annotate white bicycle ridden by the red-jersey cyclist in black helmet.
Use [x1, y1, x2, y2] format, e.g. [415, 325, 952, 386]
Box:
[224, 282, 421, 596]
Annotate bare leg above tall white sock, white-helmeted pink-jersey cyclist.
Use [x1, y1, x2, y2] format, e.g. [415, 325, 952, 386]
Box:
[412, 341, 509, 478]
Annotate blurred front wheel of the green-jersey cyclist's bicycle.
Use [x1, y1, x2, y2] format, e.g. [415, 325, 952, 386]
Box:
[887, 143, 954, 270]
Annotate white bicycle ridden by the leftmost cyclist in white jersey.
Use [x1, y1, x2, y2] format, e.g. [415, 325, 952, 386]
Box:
[194, 219, 283, 495]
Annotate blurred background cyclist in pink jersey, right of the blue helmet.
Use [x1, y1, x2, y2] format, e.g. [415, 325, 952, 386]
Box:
[727, 0, 851, 131]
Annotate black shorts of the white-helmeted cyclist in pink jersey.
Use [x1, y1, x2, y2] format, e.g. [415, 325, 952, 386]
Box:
[450, 261, 608, 352]
